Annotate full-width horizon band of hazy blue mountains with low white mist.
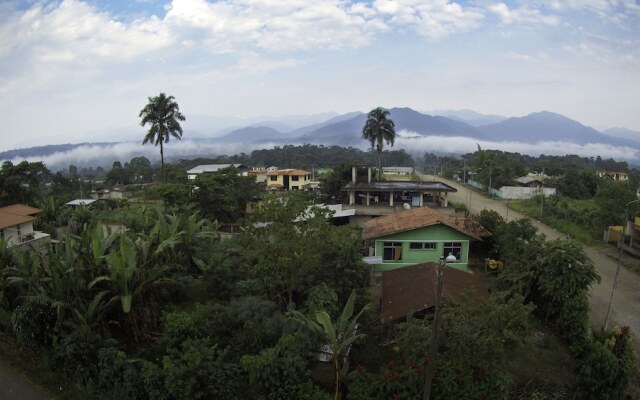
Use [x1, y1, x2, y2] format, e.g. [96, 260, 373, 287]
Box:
[0, 107, 640, 167]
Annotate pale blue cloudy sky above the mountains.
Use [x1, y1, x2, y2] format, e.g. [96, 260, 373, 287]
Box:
[0, 0, 640, 151]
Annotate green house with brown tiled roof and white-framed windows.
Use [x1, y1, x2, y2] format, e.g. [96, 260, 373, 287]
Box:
[362, 207, 489, 272]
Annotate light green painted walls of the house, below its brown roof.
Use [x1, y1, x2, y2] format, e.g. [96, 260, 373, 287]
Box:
[375, 225, 475, 272]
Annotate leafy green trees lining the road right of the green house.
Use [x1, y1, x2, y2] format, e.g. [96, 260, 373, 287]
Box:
[479, 210, 637, 399]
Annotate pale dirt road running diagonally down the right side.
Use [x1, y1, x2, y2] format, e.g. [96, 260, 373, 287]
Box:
[423, 175, 640, 353]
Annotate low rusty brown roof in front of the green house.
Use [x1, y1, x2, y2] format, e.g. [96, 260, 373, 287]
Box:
[380, 263, 489, 324]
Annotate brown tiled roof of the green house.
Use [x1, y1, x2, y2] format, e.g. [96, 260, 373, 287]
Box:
[362, 207, 491, 240]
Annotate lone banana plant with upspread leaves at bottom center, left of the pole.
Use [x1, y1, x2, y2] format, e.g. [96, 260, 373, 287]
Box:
[289, 290, 369, 400]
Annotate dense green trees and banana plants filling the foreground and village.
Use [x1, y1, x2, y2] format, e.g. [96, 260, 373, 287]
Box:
[0, 139, 636, 400]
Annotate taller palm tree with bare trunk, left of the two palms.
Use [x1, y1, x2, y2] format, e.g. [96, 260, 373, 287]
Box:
[138, 92, 185, 184]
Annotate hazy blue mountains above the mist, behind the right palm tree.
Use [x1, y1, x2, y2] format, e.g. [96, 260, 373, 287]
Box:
[215, 108, 640, 149]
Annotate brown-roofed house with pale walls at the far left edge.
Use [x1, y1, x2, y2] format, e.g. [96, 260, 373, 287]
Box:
[0, 204, 51, 247]
